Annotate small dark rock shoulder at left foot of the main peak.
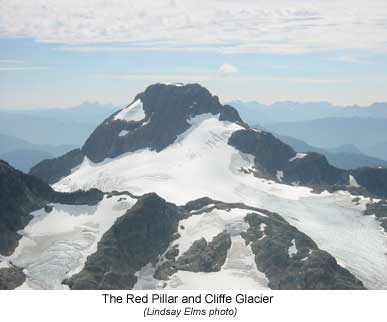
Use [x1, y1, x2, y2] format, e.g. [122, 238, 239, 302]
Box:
[29, 149, 84, 184]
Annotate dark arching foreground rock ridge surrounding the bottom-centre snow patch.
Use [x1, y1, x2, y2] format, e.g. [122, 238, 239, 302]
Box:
[64, 194, 364, 289]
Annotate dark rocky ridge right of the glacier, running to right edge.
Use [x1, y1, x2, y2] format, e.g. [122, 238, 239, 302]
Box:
[228, 129, 387, 198]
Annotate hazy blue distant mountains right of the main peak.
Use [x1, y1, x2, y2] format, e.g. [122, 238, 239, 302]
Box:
[230, 101, 387, 166]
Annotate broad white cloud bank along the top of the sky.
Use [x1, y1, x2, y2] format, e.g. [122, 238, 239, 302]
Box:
[0, 0, 387, 54]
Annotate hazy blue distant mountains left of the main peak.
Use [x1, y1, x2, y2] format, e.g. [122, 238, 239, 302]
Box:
[0, 102, 118, 172]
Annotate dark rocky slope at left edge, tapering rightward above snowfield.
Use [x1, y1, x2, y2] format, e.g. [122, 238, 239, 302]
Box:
[0, 161, 103, 255]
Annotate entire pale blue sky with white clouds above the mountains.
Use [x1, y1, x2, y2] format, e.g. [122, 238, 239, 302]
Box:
[0, 0, 387, 109]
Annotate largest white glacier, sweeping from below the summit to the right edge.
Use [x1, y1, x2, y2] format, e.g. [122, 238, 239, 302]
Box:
[47, 114, 387, 289]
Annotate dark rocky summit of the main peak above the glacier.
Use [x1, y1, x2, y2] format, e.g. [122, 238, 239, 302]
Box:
[82, 84, 247, 162]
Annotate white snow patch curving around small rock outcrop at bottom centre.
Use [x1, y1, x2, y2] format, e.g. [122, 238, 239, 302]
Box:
[166, 209, 269, 290]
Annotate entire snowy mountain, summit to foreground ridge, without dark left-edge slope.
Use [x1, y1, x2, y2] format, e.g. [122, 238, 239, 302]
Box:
[0, 84, 387, 289]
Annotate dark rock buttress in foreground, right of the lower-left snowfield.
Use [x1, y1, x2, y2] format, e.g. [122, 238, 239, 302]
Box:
[64, 194, 181, 290]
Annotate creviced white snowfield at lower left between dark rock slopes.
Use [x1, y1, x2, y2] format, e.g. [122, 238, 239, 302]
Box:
[7, 196, 136, 289]
